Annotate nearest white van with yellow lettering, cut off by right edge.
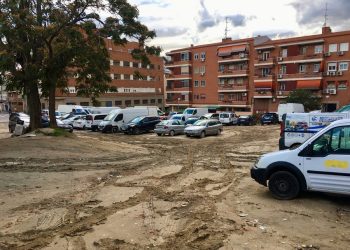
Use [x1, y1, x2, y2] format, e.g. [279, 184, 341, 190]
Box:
[251, 119, 350, 200]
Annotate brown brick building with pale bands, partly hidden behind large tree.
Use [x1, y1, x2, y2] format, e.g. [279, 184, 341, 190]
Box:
[47, 39, 164, 108]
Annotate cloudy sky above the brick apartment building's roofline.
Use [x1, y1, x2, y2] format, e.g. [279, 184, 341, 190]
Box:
[129, 0, 350, 52]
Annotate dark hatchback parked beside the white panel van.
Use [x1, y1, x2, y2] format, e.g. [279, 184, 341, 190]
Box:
[122, 116, 160, 135]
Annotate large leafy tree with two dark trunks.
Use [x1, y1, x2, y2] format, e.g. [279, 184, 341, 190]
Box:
[0, 0, 160, 129]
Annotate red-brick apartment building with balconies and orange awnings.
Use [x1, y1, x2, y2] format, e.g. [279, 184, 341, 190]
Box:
[166, 27, 350, 113]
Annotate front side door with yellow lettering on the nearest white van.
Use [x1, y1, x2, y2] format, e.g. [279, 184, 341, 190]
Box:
[303, 126, 350, 194]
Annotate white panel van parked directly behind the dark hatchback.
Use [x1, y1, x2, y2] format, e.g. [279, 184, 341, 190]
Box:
[98, 108, 158, 133]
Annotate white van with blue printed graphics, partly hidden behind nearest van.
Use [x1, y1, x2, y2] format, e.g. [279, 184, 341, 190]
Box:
[279, 113, 350, 149]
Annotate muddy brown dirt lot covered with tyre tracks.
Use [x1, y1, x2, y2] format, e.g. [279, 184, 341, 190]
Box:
[0, 123, 350, 249]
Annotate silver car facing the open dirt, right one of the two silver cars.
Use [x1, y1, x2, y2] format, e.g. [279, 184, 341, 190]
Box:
[185, 119, 223, 138]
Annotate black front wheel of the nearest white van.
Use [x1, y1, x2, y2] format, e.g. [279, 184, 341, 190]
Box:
[269, 171, 300, 200]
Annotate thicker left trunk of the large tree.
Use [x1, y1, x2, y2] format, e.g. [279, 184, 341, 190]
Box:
[25, 82, 41, 131]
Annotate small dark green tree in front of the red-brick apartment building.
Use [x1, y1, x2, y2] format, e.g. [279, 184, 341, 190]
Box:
[285, 89, 321, 111]
